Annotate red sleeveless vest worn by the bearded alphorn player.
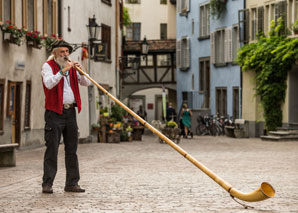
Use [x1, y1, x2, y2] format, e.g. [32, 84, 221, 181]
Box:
[42, 60, 81, 114]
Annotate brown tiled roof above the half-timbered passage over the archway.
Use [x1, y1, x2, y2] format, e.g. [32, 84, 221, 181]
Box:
[123, 39, 176, 53]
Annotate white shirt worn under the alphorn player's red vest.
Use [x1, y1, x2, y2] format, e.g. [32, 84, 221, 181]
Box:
[41, 63, 91, 104]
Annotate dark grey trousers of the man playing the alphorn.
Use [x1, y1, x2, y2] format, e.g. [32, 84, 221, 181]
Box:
[42, 107, 80, 186]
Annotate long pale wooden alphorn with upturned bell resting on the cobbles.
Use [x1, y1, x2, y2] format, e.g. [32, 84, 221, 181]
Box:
[66, 58, 275, 207]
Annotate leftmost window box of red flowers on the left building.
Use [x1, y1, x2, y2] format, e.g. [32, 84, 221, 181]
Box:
[1, 20, 24, 46]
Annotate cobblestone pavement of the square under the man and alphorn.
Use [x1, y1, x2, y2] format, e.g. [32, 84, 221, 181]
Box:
[0, 135, 298, 213]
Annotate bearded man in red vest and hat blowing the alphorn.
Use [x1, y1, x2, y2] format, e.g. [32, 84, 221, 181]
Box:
[41, 40, 90, 193]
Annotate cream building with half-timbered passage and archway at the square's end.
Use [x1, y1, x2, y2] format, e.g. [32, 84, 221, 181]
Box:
[122, 0, 176, 122]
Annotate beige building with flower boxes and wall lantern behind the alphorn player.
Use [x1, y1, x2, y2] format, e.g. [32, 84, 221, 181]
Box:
[0, 0, 121, 146]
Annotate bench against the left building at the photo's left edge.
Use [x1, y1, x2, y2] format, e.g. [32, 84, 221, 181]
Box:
[0, 143, 19, 167]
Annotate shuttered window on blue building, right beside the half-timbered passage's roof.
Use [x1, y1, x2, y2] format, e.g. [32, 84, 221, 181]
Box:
[176, 37, 190, 70]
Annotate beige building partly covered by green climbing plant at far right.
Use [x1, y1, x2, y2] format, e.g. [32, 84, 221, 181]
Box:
[242, 0, 298, 137]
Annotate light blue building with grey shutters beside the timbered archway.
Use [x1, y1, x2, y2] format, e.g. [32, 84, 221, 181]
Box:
[176, 0, 244, 123]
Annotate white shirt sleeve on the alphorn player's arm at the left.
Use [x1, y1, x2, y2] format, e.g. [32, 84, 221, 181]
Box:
[41, 63, 63, 89]
